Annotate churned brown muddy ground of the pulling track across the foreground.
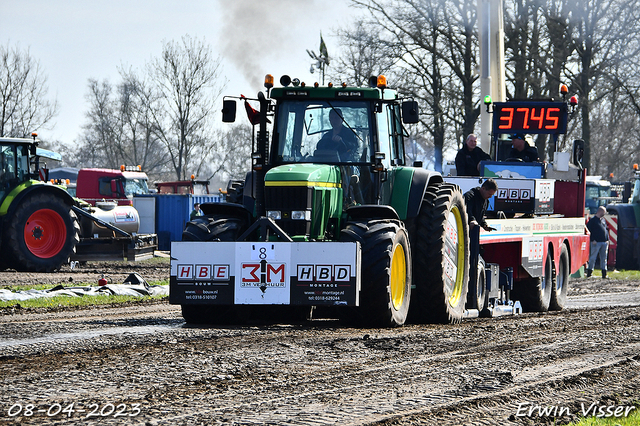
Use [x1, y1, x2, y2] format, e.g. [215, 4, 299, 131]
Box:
[0, 264, 640, 425]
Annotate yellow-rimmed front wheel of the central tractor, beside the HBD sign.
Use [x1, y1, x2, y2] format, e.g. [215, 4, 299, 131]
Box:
[340, 220, 411, 327]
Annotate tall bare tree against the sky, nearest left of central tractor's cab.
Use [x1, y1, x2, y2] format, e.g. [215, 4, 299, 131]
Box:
[147, 36, 226, 180]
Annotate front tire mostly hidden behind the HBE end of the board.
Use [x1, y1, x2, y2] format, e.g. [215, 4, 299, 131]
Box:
[182, 215, 247, 324]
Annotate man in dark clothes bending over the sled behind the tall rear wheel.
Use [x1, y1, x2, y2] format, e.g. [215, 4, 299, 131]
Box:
[464, 179, 498, 308]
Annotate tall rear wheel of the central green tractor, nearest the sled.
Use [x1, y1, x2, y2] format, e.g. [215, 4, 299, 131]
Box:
[411, 183, 469, 323]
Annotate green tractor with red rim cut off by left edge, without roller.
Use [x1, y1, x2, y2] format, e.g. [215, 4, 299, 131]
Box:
[0, 134, 80, 272]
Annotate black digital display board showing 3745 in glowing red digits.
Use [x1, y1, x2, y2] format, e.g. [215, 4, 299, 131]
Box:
[493, 101, 567, 134]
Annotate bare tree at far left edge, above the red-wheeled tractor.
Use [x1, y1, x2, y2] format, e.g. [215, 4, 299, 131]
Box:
[0, 43, 58, 137]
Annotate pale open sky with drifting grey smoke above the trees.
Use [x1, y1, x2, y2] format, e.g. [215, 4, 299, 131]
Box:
[0, 0, 358, 143]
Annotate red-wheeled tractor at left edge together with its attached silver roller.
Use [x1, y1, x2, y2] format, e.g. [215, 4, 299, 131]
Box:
[0, 134, 157, 272]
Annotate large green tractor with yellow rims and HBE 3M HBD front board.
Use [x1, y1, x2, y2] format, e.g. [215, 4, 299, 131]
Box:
[170, 75, 469, 327]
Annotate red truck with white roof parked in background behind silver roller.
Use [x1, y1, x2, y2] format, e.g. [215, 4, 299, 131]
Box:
[76, 166, 149, 206]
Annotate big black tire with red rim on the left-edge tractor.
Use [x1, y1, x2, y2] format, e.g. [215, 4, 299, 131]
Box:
[3, 193, 80, 272]
